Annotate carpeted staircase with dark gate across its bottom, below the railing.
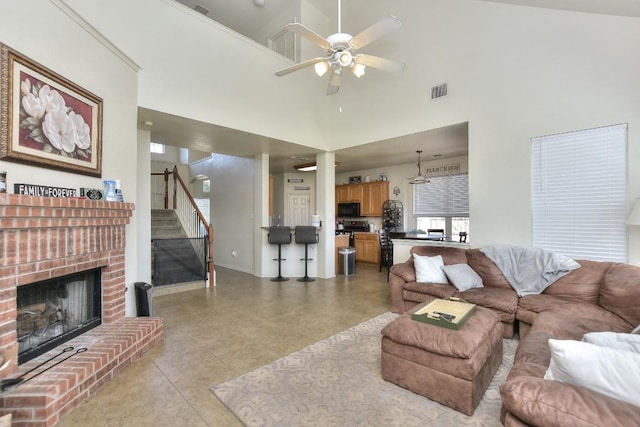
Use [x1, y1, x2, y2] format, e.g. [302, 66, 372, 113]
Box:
[151, 209, 206, 287]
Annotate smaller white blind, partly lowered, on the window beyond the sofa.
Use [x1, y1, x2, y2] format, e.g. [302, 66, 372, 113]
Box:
[413, 174, 469, 217]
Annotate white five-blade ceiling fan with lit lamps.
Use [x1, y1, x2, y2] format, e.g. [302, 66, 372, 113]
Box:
[275, 0, 404, 95]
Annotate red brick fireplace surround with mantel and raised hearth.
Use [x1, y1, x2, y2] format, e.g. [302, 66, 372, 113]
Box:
[0, 194, 163, 426]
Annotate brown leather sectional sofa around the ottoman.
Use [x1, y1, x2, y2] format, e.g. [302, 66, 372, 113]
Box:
[389, 246, 640, 426]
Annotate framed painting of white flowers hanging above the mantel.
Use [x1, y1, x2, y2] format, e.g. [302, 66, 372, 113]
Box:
[0, 44, 102, 177]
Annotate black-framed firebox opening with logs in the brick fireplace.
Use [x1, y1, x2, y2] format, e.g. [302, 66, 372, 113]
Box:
[17, 269, 102, 364]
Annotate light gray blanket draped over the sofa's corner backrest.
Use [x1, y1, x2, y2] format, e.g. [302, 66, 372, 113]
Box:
[480, 245, 580, 297]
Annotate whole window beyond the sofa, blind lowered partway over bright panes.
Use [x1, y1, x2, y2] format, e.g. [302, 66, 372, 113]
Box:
[413, 174, 469, 240]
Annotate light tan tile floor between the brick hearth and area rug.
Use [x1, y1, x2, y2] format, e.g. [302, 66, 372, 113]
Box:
[58, 264, 389, 427]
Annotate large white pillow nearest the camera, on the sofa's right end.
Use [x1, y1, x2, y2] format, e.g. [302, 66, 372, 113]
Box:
[544, 339, 640, 406]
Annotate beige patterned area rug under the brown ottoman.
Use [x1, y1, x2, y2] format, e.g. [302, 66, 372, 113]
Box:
[211, 313, 517, 427]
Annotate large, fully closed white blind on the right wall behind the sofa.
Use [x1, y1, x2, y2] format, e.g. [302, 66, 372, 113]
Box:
[531, 124, 628, 262]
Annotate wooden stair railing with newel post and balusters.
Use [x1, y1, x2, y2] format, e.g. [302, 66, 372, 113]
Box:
[151, 166, 215, 286]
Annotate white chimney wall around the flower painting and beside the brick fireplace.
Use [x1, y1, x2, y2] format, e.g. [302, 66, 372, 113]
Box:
[0, 0, 141, 315]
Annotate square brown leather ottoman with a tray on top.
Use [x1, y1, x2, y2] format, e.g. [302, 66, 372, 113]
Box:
[382, 304, 502, 415]
